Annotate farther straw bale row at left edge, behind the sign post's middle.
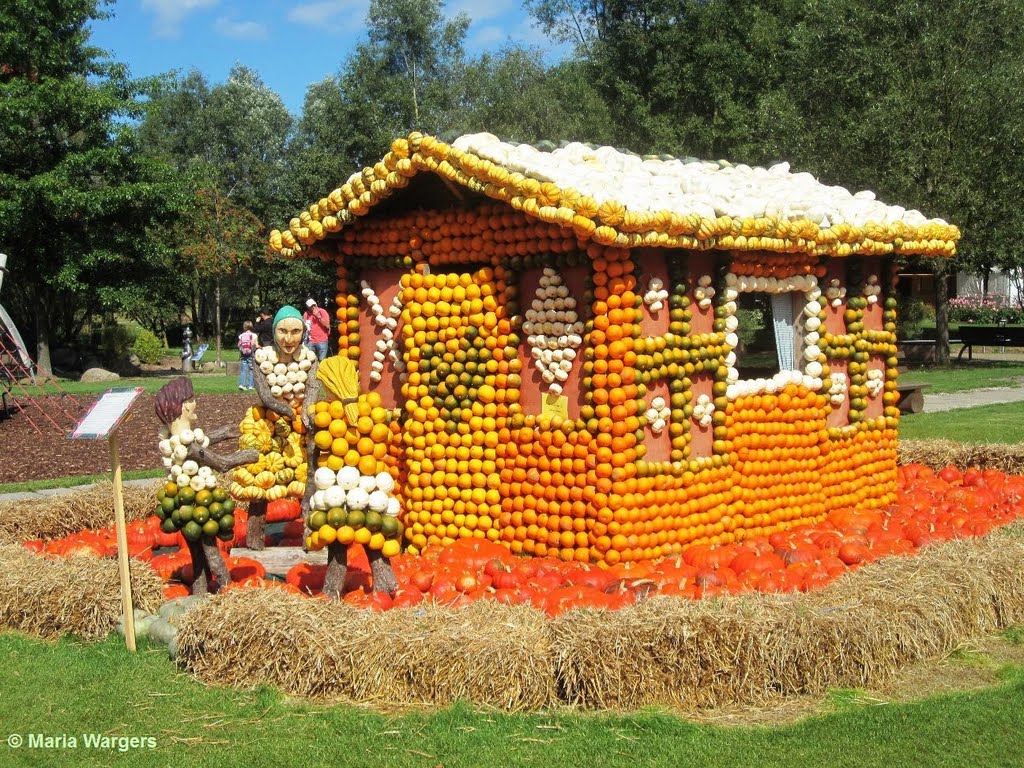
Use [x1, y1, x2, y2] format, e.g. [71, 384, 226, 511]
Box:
[0, 480, 160, 544]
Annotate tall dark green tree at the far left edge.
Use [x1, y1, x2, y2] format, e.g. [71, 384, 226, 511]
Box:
[0, 0, 183, 373]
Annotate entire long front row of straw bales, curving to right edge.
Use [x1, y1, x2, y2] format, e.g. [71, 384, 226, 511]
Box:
[178, 524, 1024, 711]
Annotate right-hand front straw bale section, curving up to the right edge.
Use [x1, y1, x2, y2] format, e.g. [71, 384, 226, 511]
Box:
[551, 524, 1024, 710]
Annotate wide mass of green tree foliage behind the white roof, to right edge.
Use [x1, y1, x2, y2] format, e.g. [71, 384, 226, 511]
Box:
[526, 0, 1024, 360]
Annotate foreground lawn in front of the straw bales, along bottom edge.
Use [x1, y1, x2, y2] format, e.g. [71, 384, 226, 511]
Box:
[0, 633, 1024, 768]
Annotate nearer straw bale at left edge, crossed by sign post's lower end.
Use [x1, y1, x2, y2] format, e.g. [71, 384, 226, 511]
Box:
[0, 545, 164, 640]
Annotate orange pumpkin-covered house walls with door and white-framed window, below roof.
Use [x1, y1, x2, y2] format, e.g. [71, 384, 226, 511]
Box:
[319, 203, 899, 563]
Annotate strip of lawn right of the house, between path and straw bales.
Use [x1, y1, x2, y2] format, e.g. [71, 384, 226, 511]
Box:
[899, 402, 1024, 444]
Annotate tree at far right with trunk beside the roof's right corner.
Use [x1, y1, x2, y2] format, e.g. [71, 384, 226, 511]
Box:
[784, 0, 1024, 362]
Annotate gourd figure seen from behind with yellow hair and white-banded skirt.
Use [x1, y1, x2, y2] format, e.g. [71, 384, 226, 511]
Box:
[302, 356, 402, 597]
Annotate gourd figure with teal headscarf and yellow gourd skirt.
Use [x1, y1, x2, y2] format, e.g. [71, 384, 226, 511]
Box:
[230, 306, 316, 550]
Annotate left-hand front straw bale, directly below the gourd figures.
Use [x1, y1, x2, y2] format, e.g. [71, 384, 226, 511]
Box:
[178, 590, 555, 710]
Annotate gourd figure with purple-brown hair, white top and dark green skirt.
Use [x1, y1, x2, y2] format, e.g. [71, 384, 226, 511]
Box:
[156, 377, 259, 594]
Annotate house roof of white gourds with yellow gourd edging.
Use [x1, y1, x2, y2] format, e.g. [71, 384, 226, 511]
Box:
[270, 133, 959, 257]
